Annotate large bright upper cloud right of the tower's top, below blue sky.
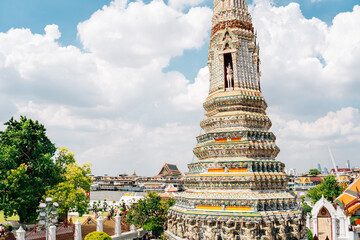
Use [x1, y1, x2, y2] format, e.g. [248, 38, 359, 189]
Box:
[251, 0, 360, 119]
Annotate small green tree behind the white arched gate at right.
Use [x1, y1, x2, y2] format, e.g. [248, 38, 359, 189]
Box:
[307, 175, 342, 203]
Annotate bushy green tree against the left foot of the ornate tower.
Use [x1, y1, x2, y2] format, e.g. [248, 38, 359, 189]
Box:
[126, 193, 175, 237]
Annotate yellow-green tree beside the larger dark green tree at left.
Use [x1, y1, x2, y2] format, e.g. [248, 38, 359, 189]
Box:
[46, 148, 92, 218]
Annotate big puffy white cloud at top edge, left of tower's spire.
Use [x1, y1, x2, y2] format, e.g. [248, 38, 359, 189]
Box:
[78, 1, 211, 68]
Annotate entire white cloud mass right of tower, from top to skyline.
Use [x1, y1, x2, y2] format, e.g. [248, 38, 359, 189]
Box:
[251, 0, 360, 171]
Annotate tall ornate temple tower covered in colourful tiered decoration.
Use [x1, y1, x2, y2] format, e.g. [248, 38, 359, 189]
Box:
[166, 0, 306, 240]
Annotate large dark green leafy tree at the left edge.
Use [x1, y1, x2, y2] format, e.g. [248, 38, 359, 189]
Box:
[0, 116, 60, 222]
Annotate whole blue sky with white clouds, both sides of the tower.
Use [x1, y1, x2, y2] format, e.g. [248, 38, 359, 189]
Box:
[0, 0, 360, 176]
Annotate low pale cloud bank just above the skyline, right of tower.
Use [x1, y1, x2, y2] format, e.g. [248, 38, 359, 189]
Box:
[270, 107, 360, 171]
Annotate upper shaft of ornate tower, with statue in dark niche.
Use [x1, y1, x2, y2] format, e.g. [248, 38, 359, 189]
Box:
[208, 0, 260, 93]
